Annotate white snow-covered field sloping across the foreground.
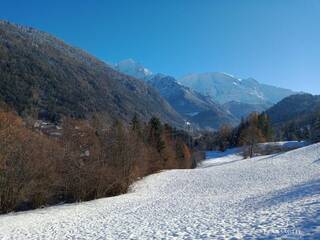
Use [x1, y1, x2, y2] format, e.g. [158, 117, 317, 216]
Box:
[0, 144, 320, 240]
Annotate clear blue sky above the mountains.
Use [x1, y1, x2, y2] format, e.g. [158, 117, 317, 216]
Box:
[0, 0, 320, 94]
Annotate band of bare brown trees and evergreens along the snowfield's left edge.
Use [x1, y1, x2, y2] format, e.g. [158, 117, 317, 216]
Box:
[0, 110, 200, 213]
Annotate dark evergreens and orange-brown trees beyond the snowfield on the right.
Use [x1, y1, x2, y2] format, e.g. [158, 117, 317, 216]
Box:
[196, 112, 320, 157]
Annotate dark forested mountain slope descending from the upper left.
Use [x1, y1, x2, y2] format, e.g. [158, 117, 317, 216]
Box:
[0, 21, 183, 125]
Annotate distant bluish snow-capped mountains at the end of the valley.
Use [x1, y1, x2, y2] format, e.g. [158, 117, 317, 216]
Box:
[114, 59, 294, 129]
